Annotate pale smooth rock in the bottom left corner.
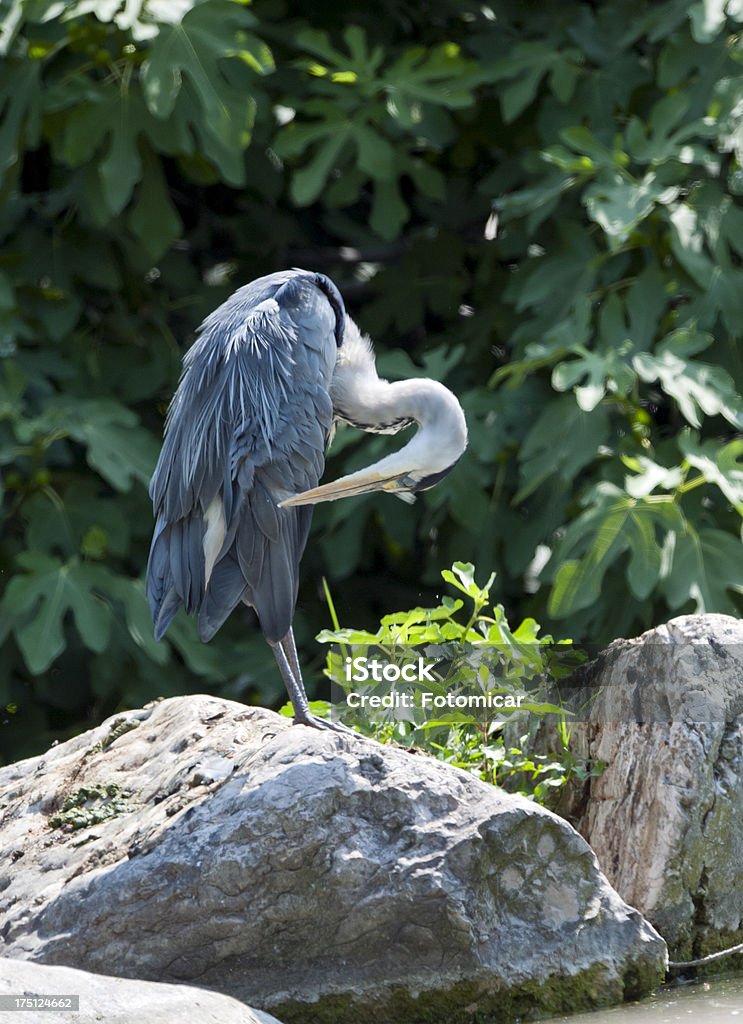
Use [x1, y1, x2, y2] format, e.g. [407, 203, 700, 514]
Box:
[0, 956, 279, 1024]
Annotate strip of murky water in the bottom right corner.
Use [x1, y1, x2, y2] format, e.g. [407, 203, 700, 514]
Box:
[553, 978, 743, 1024]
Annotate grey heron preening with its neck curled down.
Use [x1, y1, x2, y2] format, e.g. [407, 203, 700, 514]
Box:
[147, 270, 467, 728]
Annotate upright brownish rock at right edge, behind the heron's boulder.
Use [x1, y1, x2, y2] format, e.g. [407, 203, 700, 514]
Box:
[573, 615, 743, 959]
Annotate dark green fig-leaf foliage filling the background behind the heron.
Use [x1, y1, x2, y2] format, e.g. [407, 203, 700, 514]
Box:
[0, 0, 743, 760]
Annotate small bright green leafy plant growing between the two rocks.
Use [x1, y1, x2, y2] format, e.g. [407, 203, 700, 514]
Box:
[294, 562, 602, 804]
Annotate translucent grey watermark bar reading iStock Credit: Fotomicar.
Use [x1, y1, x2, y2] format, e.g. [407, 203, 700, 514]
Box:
[325, 641, 743, 729]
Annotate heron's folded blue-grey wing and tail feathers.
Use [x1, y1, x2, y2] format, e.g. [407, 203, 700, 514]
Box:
[147, 273, 338, 640]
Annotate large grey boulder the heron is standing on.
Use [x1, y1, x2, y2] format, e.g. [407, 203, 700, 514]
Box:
[0, 696, 665, 1024]
